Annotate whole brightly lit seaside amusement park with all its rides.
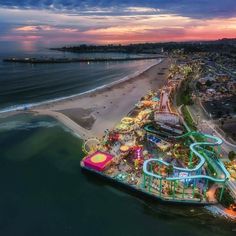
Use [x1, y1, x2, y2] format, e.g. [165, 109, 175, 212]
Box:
[81, 86, 230, 205]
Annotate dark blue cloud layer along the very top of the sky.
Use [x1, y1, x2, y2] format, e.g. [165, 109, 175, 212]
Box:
[0, 0, 236, 18]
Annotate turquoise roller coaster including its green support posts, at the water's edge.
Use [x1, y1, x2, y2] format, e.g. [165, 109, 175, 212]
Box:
[142, 132, 230, 200]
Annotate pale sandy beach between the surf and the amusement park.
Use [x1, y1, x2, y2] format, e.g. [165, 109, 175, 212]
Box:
[28, 58, 170, 139]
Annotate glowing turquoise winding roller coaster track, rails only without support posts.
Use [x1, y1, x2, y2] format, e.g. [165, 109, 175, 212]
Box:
[143, 126, 230, 183]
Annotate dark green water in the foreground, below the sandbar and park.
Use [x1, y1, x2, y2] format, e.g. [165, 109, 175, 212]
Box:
[0, 115, 236, 236]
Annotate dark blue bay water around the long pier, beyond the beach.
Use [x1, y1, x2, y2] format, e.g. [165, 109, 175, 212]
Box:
[0, 50, 160, 112]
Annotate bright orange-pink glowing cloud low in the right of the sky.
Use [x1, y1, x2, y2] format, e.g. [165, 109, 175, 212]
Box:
[81, 15, 236, 43]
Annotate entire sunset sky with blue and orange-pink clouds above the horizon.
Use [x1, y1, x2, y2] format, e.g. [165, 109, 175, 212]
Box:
[0, 0, 236, 50]
